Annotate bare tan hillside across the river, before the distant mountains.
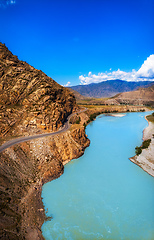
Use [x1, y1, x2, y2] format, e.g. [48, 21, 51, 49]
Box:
[114, 83, 154, 107]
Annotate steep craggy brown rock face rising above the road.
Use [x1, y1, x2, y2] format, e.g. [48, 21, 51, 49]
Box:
[0, 43, 77, 137]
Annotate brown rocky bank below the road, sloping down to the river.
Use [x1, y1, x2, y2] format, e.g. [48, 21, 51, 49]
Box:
[0, 109, 152, 240]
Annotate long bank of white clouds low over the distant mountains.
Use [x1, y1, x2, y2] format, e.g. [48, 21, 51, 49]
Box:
[79, 54, 154, 85]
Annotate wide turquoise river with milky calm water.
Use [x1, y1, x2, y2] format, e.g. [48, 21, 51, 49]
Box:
[42, 113, 154, 240]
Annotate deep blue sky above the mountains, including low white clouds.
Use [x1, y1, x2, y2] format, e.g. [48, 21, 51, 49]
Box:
[0, 0, 154, 85]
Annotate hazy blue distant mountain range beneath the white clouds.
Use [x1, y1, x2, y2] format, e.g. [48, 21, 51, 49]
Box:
[71, 79, 152, 98]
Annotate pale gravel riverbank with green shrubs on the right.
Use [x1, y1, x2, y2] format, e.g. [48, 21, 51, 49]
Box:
[130, 113, 154, 177]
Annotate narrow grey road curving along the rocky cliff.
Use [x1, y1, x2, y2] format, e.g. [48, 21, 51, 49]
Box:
[0, 108, 87, 152]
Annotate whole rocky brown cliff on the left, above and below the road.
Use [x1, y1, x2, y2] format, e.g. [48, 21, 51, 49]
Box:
[0, 43, 89, 240]
